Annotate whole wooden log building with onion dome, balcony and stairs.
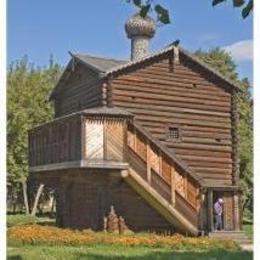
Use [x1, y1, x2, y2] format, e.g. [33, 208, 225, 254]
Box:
[29, 12, 241, 235]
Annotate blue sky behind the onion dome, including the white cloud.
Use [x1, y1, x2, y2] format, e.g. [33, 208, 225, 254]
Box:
[7, 0, 253, 81]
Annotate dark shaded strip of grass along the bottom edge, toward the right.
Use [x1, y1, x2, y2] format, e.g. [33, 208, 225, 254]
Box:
[75, 250, 253, 260]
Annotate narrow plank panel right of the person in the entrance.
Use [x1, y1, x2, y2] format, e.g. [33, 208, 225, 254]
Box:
[223, 192, 234, 230]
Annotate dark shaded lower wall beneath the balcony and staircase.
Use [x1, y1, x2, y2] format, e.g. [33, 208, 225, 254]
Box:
[57, 170, 176, 232]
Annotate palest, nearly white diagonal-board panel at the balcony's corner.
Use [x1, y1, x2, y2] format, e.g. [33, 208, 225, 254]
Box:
[85, 121, 104, 159]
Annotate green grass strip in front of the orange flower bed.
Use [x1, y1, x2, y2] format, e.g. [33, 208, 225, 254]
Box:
[7, 245, 253, 260]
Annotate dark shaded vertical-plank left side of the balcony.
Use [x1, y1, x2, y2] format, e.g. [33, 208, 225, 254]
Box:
[29, 115, 82, 167]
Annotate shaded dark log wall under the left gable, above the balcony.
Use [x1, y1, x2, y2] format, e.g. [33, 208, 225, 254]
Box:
[54, 64, 102, 117]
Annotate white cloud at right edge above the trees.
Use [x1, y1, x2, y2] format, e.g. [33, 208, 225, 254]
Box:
[223, 39, 253, 61]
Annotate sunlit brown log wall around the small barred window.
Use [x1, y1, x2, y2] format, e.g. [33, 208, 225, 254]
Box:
[109, 53, 232, 185]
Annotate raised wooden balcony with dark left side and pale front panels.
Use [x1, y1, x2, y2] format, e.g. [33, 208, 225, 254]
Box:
[29, 107, 132, 172]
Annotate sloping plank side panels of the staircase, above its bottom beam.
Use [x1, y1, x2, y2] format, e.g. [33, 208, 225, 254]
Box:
[127, 123, 201, 226]
